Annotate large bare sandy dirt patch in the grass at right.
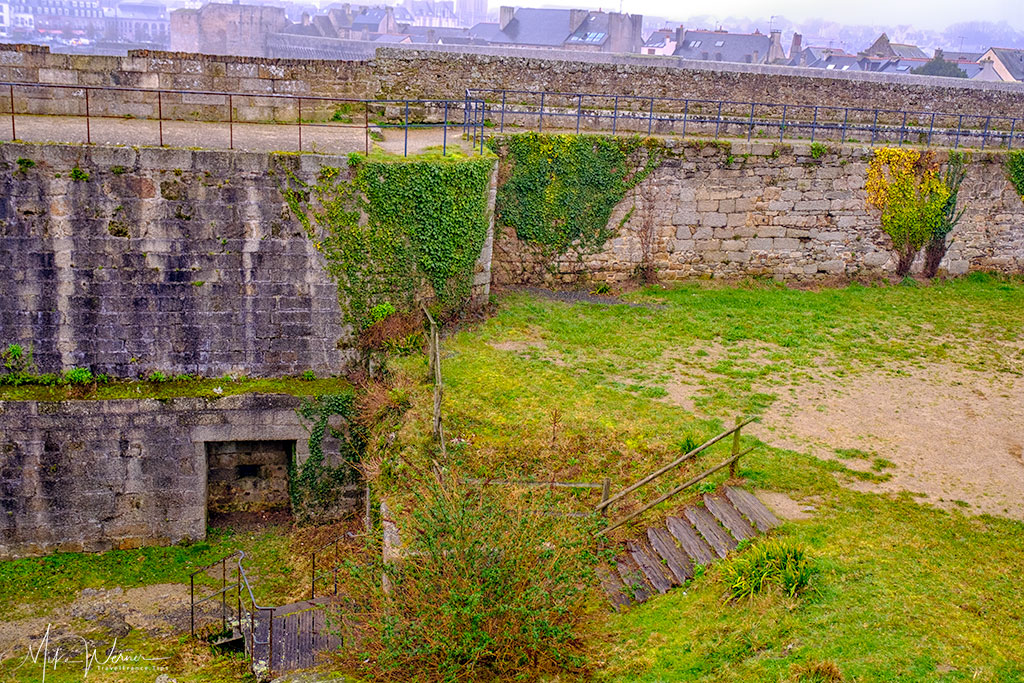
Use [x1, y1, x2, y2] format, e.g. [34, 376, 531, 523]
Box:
[754, 364, 1024, 519]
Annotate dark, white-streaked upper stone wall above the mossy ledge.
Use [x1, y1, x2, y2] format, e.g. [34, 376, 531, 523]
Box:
[0, 143, 351, 377]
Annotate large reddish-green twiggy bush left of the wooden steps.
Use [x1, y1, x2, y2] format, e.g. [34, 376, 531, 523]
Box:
[344, 477, 594, 681]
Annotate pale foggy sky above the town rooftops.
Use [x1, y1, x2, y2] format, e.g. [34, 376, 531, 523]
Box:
[618, 0, 1024, 30]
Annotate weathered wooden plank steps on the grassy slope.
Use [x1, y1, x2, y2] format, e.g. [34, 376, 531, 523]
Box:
[598, 486, 779, 609]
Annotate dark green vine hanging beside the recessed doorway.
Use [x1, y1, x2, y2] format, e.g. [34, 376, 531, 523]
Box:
[288, 391, 366, 512]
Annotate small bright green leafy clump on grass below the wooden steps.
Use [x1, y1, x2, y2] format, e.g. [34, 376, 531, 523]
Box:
[722, 540, 814, 601]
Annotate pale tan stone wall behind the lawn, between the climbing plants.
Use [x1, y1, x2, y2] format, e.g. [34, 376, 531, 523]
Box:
[493, 140, 1024, 285]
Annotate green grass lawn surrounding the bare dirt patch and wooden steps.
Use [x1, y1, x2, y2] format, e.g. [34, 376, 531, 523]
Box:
[425, 275, 1024, 681]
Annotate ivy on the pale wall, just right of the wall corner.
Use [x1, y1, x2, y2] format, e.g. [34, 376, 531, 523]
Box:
[488, 133, 665, 256]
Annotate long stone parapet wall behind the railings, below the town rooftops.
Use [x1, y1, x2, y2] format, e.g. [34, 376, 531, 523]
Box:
[0, 45, 1024, 125]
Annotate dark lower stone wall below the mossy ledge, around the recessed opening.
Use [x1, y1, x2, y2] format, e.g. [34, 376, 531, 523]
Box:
[0, 394, 325, 559]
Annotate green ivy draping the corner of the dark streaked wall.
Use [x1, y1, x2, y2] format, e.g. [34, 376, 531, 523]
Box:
[283, 155, 494, 330]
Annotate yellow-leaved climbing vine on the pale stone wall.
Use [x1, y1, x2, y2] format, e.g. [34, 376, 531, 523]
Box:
[865, 147, 950, 278]
